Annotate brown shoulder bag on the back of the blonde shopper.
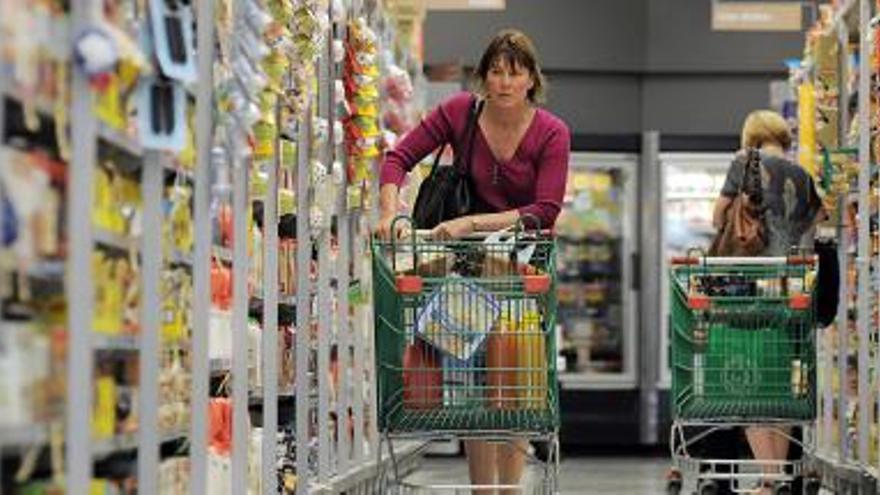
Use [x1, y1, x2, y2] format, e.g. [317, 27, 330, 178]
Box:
[709, 149, 767, 256]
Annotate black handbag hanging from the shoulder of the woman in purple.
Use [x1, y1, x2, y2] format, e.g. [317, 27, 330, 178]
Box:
[412, 97, 483, 229]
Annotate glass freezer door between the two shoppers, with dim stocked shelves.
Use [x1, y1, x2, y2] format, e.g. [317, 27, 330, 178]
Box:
[556, 153, 638, 389]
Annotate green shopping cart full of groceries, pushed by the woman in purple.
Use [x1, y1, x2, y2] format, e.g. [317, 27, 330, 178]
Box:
[372, 218, 559, 494]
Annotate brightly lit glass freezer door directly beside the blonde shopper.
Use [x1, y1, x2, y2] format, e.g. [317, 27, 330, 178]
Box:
[658, 153, 733, 389]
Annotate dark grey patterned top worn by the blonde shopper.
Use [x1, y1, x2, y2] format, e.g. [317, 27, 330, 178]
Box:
[721, 152, 822, 256]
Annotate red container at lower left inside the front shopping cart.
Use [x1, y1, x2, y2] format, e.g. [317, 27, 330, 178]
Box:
[403, 342, 443, 409]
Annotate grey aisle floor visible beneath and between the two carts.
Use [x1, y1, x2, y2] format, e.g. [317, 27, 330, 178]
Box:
[409, 457, 669, 495]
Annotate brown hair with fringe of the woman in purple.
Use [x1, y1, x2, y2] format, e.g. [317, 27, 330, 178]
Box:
[477, 29, 547, 103]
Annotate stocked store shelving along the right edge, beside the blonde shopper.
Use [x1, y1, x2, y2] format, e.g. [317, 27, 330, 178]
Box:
[801, 0, 880, 493]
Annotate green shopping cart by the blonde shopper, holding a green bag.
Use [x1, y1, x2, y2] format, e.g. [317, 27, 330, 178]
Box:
[667, 251, 819, 495]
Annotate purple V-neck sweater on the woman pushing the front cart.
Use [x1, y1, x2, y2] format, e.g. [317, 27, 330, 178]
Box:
[380, 92, 570, 228]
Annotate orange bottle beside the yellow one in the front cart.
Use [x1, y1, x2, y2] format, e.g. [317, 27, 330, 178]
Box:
[486, 318, 519, 410]
